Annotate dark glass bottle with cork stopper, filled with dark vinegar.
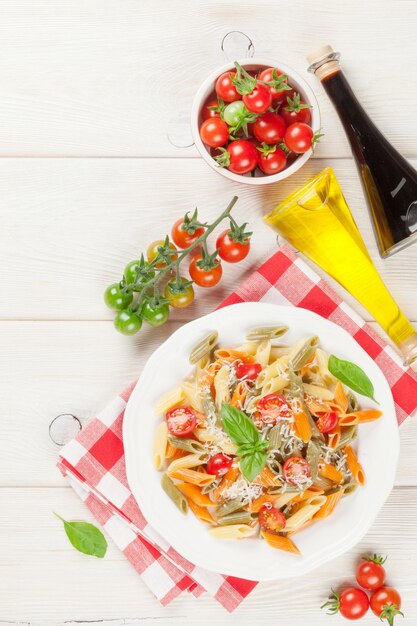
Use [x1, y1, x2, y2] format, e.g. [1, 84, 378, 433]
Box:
[307, 46, 417, 257]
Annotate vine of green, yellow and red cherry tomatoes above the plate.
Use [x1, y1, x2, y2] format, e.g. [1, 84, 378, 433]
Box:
[104, 207, 252, 335]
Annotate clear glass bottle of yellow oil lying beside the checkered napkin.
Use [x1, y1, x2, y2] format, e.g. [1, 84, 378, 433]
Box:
[265, 168, 417, 367]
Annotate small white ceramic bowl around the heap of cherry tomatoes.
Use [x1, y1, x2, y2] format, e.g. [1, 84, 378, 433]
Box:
[191, 57, 320, 185]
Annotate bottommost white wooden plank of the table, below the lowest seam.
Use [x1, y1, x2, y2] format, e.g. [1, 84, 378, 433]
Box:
[0, 488, 417, 626]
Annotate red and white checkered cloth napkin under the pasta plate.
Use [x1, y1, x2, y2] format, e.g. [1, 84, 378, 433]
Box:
[58, 246, 417, 611]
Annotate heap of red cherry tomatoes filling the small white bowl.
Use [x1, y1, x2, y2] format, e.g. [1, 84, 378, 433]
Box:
[200, 63, 321, 175]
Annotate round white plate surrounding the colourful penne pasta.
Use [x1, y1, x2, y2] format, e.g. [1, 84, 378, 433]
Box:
[123, 302, 399, 580]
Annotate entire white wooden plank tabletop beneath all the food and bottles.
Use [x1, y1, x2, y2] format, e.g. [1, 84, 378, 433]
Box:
[0, 0, 417, 626]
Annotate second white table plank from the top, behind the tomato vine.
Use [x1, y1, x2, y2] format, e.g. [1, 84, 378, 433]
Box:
[0, 159, 417, 320]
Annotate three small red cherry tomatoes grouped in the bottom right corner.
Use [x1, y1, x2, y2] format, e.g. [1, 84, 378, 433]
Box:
[322, 554, 404, 626]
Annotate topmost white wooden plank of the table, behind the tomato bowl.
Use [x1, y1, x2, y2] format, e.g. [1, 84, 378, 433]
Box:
[0, 0, 417, 157]
